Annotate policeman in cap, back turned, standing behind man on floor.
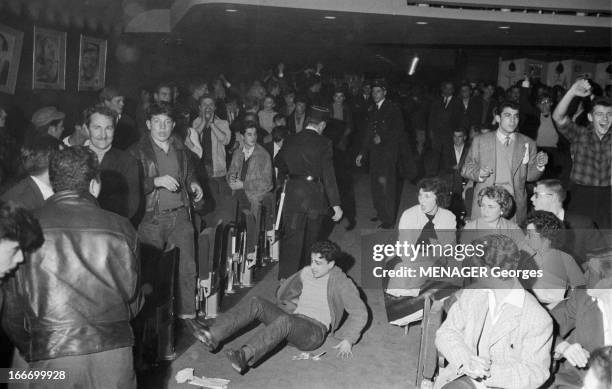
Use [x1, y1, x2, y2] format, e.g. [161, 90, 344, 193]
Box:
[275, 106, 342, 279]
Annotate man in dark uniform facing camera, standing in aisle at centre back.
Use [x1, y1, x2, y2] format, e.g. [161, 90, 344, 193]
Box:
[355, 80, 404, 228]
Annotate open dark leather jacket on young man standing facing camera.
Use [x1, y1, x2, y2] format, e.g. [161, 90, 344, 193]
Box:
[129, 135, 197, 214]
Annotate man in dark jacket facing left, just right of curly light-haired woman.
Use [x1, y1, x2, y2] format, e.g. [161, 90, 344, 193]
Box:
[531, 179, 605, 265]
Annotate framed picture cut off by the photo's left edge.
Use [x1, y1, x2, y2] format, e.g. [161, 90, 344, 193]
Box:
[0, 24, 23, 94]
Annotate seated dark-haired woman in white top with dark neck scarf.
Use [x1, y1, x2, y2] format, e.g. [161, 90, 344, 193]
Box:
[387, 178, 457, 295]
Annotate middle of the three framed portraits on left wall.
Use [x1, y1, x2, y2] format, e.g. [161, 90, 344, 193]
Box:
[32, 26, 66, 89]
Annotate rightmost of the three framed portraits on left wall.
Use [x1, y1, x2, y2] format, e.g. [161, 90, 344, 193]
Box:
[78, 35, 106, 91]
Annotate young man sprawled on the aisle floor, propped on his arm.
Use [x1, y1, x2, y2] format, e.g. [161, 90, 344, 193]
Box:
[188, 241, 368, 374]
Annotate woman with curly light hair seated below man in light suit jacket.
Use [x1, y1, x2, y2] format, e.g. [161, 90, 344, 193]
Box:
[459, 186, 530, 251]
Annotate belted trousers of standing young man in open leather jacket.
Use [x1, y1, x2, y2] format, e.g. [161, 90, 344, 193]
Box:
[138, 208, 197, 315]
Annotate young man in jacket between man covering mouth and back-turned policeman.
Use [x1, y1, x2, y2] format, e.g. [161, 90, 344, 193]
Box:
[227, 123, 272, 260]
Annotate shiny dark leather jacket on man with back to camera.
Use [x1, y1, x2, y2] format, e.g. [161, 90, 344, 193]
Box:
[2, 191, 142, 361]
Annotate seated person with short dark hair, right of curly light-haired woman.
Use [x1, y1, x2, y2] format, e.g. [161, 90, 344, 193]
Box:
[527, 211, 586, 309]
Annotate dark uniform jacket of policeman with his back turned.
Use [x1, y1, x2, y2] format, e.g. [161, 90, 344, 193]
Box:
[275, 129, 340, 215]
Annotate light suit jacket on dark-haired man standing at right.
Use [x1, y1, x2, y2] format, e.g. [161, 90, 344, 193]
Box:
[461, 131, 542, 225]
